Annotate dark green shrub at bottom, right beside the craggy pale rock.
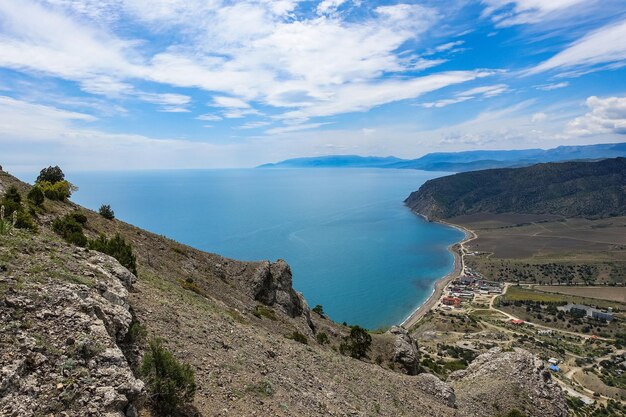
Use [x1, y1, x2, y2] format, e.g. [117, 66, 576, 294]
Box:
[141, 339, 196, 415]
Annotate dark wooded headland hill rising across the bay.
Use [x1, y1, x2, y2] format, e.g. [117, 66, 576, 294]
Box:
[406, 158, 626, 219]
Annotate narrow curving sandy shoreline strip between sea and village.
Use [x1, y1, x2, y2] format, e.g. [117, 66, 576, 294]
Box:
[400, 212, 478, 329]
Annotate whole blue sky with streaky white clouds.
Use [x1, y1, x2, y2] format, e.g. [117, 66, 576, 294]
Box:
[0, 0, 626, 172]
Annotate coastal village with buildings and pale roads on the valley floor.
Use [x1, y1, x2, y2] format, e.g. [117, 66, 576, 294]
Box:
[425, 256, 626, 415]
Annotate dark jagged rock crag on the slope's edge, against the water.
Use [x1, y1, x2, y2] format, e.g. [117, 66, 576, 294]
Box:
[248, 259, 311, 322]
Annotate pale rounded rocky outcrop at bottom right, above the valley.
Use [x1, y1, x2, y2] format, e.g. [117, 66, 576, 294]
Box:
[448, 348, 568, 417]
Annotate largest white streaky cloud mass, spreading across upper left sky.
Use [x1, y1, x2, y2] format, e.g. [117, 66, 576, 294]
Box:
[0, 0, 458, 123]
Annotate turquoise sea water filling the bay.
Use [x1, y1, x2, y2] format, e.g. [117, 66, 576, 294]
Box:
[69, 169, 463, 329]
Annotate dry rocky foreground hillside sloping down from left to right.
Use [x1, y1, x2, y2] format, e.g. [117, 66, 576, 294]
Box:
[0, 167, 567, 417]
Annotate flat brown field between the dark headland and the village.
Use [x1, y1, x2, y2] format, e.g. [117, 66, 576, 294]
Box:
[449, 214, 626, 285]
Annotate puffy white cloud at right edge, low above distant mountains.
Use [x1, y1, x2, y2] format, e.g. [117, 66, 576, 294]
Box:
[568, 96, 626, 136]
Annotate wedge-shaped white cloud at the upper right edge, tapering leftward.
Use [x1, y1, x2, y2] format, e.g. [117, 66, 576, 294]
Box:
[527, 20, 626, 74]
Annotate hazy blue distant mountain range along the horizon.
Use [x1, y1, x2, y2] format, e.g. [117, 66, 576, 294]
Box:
[259, 143, 626, 172]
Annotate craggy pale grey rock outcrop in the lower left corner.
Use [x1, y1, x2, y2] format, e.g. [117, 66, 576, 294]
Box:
[0, 244, 144, 417]
